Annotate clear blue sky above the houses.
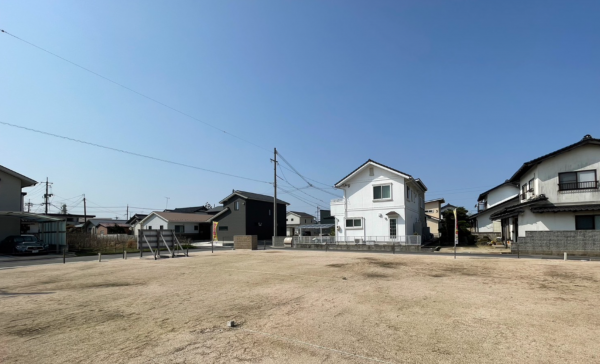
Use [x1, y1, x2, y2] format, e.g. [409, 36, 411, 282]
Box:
[0, 0, 600, 217]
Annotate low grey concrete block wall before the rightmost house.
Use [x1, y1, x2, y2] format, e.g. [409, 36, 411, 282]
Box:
[511, 230, 600, 257]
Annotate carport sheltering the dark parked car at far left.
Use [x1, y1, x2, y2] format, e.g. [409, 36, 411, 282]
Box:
[0, 211, 67, 253]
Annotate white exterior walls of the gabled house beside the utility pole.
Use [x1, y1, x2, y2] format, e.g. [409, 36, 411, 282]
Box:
[331, 166, 426, 238]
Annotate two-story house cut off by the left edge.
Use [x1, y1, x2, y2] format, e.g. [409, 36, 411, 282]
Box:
[0, 166, 37, 241]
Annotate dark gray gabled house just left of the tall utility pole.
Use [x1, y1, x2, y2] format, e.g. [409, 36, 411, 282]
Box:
[209, 190, 289, 241]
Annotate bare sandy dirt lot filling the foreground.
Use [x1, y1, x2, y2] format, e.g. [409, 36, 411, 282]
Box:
[0, 250, 600, 363]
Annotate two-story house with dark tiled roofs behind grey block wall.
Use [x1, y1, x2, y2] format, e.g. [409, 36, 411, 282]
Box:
[490, 135, 600, 241]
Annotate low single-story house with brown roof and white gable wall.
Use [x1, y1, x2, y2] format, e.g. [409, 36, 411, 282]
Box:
[133, 211, 213, 240]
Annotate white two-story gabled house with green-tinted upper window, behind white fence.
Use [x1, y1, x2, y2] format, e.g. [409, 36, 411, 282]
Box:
[331, 159, 427, 242]
